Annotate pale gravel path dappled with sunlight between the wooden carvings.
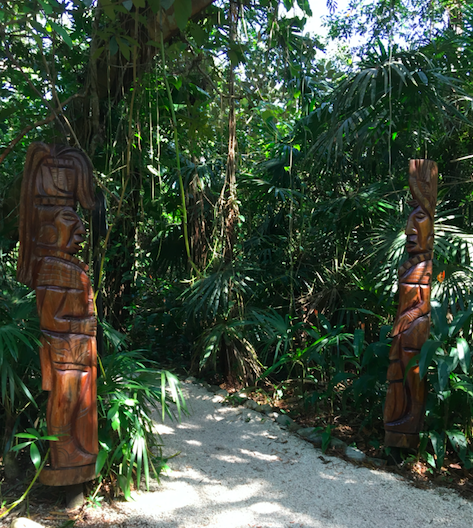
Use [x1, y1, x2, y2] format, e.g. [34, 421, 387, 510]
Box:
[74, 384, 473, 528]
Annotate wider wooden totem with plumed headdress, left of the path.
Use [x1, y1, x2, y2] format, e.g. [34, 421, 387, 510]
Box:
[17, 143, 98, 486]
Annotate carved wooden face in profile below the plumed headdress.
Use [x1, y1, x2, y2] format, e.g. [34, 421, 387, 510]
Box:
[38, 206, 85, 255]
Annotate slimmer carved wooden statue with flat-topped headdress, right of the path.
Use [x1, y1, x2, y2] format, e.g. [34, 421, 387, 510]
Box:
[384, 160, 438, 448]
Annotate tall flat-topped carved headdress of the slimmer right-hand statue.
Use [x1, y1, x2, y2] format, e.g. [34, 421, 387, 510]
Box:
[409, 159, 438, 220]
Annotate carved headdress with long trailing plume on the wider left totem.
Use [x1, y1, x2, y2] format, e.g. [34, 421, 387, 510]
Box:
[17, 143, 95, 286]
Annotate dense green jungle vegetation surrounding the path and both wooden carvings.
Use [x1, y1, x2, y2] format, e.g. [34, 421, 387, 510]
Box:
[0, 0, 473, 513]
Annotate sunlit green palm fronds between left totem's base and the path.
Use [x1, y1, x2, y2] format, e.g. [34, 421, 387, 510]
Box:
[96, 338, 186, 500]
